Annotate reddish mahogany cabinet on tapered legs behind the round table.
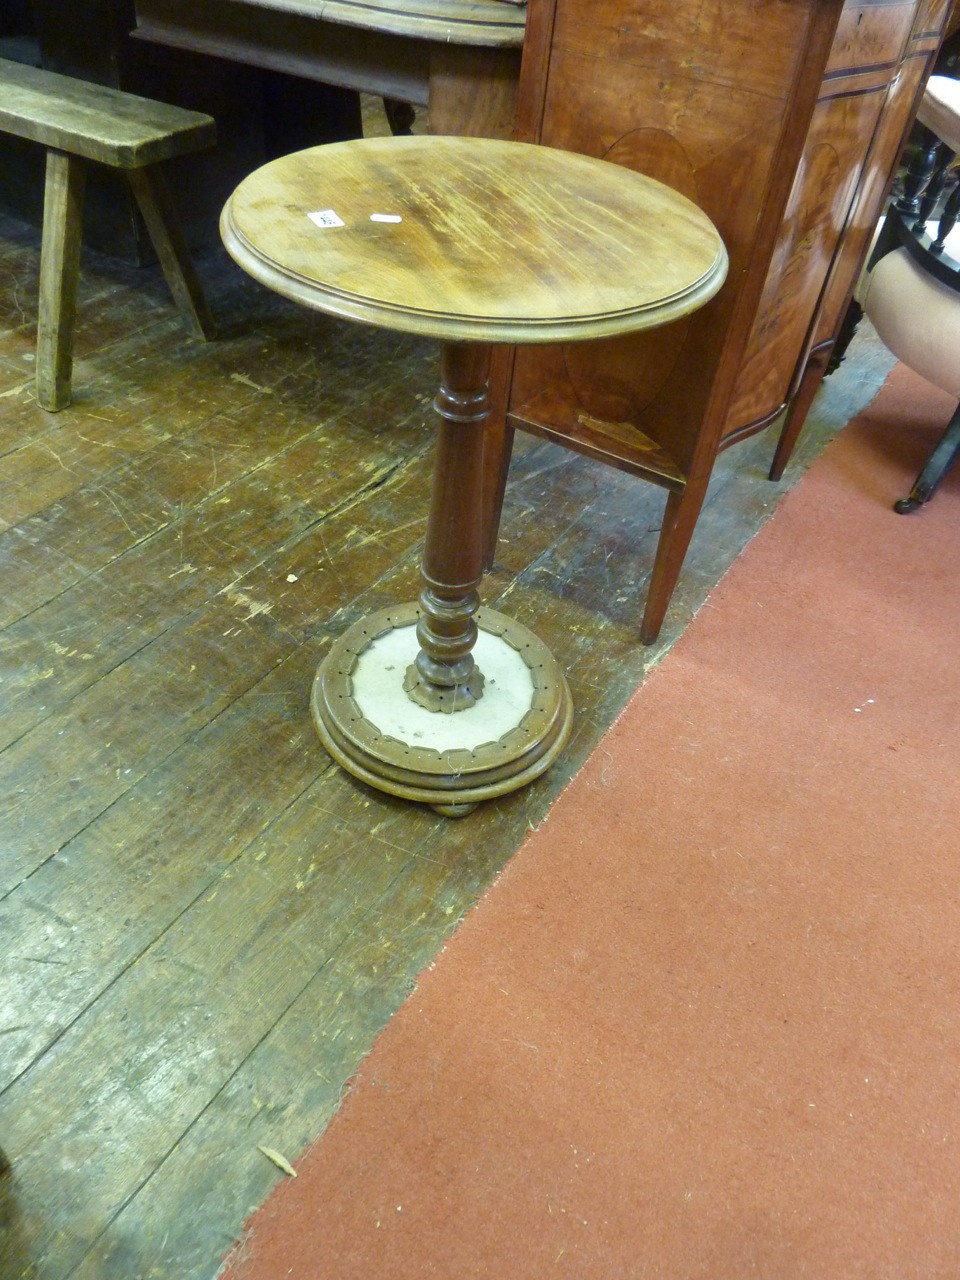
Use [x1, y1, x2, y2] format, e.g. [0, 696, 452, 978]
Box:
[486, 0, 951, 644]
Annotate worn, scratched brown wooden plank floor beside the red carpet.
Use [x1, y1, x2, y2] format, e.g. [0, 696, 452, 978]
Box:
[0, 137, 888, 1280]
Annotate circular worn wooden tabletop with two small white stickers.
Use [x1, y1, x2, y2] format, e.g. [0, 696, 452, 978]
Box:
[220, 137, 727, 343]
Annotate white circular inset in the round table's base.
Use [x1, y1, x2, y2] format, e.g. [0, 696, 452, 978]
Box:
[351, 623, 534, 751]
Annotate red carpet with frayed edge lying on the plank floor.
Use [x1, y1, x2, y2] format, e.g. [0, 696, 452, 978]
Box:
[220, 367, 960, 1280]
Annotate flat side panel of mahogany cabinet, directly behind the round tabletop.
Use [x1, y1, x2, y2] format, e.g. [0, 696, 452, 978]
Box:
[509, 0, 841, 485]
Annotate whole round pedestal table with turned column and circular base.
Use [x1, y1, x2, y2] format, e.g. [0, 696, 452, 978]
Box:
[220, 137, 727, 817]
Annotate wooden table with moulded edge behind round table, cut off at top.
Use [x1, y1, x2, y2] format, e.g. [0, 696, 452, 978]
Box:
[133, 0, 526, 138]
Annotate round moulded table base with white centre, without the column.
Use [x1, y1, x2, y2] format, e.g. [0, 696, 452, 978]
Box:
[311, 604, 573, 817]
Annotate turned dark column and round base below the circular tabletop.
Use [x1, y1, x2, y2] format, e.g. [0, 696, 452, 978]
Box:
[311, 342, 573, 818]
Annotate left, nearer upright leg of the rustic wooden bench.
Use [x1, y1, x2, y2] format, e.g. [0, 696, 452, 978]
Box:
[37, 150, 86, 412]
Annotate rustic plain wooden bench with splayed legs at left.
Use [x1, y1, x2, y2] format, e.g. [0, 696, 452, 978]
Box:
[0, 59, 216, 411]
